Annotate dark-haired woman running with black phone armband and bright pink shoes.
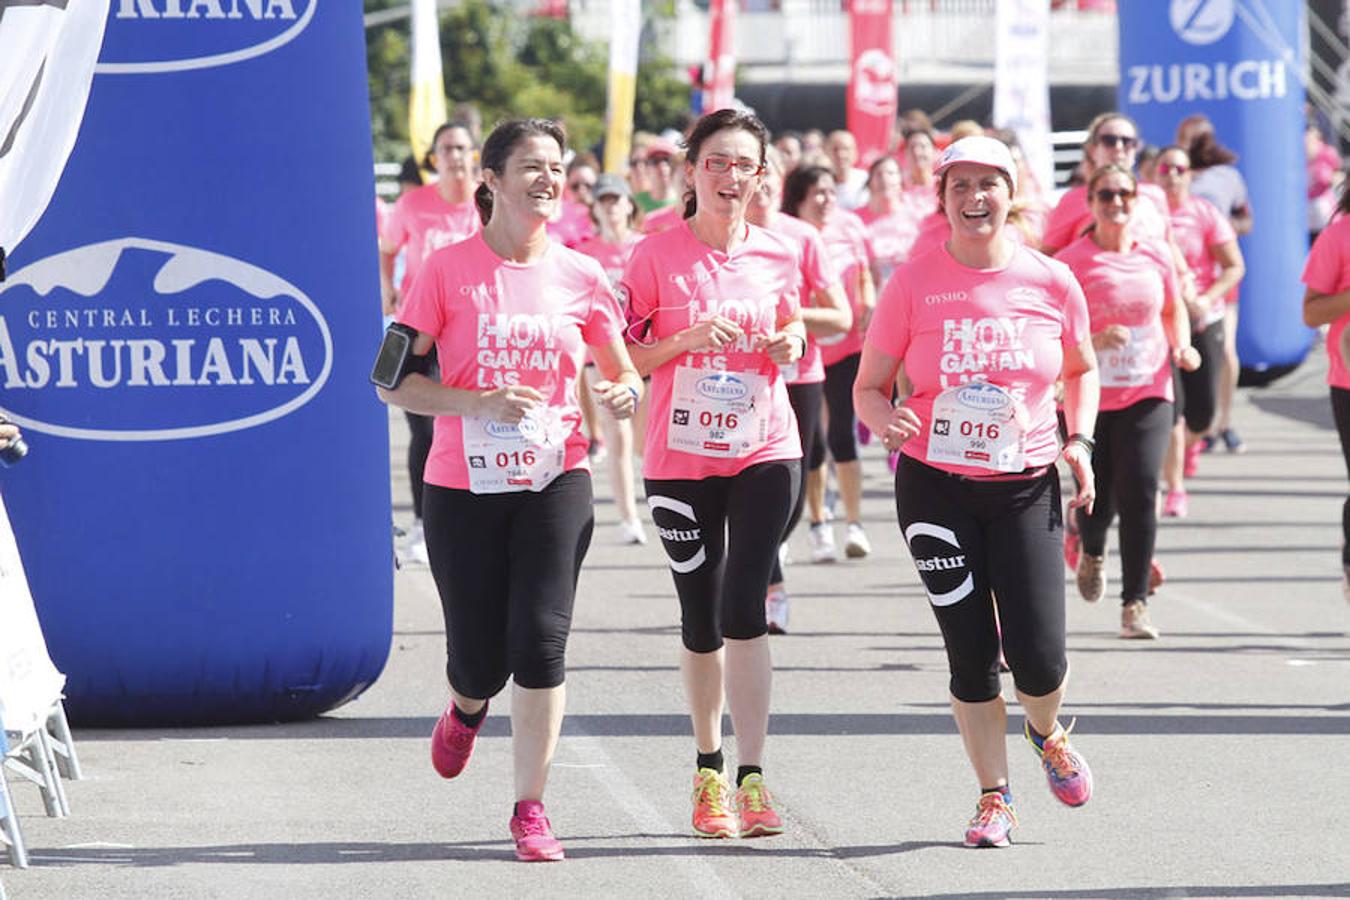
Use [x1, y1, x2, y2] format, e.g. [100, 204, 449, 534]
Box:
[381, 119, 643, 861]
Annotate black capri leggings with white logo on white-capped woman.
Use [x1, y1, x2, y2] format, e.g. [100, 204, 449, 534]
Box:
[895, 455, 1069, 703]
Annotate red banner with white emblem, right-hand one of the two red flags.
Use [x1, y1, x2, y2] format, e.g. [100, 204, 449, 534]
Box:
[848, 0, 895, 167]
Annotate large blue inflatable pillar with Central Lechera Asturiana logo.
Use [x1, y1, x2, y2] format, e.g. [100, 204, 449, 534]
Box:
[0, 0, 392, 723]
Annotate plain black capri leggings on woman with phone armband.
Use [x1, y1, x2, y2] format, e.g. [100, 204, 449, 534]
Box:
[424, 470, 595, 699]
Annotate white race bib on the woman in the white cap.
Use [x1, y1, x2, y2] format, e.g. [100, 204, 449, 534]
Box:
[927, 382, 1026, 472]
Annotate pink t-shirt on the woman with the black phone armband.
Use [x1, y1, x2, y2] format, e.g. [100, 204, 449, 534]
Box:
[398, 233, 624, 490]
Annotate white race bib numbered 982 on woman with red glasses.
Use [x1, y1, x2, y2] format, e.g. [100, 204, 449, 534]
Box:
[666, 366, 771, 459]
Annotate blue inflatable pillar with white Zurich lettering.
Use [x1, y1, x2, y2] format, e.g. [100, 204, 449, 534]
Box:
[1119, 0, 1312, 370]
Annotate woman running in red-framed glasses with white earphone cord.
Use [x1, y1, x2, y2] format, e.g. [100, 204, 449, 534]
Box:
[620, 109, 806, 838]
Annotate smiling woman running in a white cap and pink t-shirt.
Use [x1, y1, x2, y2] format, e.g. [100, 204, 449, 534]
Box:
[853, 136, 1098, 847]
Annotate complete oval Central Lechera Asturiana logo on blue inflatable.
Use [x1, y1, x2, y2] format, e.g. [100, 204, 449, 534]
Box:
[0, 237, 332, 441]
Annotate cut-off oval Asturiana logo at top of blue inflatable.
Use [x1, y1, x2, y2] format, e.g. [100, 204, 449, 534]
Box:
[96, 0, 319, 74]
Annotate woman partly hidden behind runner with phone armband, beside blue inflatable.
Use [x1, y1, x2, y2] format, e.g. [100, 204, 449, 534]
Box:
[379, 123, 481, 563]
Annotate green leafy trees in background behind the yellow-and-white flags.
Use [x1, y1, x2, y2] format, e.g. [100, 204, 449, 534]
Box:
[366, 0, 689, 159]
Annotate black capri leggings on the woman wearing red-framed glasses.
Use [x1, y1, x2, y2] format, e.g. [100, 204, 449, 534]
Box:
[645, 459, 802, 653]
